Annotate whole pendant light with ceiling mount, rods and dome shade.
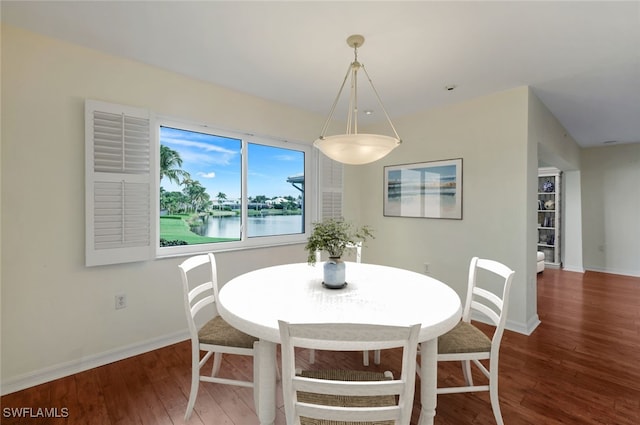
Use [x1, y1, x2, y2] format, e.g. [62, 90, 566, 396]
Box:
[313, 35, 402, 165]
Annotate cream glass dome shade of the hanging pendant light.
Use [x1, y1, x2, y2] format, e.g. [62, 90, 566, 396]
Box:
[313, 133, 400, 165]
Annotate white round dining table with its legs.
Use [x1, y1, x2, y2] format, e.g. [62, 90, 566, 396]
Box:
[218, 262, 462, 425]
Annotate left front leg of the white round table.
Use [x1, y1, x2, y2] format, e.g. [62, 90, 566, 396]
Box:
[253, 340, 276, 425]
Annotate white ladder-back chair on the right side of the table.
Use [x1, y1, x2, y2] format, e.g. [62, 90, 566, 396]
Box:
[420, 257, 515, 425]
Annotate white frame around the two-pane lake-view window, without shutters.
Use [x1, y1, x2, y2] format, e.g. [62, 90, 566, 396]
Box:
[154, 117, 318, 258]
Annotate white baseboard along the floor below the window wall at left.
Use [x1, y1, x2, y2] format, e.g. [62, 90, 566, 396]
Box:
[0, 330, 189, 395]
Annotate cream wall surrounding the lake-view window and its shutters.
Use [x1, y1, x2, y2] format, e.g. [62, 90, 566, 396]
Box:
[2, 26, 324, 392]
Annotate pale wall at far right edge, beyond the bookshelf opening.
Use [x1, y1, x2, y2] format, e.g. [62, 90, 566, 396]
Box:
[581, 144, 640, 276]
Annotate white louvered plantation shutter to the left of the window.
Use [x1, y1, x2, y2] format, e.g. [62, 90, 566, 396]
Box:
[85, 100, 155, 266]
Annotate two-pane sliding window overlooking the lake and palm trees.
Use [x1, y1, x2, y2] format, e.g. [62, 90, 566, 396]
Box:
[158, 121, 310, 256]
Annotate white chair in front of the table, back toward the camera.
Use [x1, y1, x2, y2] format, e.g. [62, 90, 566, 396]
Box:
[279, 321, 420, 425]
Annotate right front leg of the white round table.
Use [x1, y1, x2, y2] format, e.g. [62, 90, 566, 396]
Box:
[418, 338, 438, 425]
